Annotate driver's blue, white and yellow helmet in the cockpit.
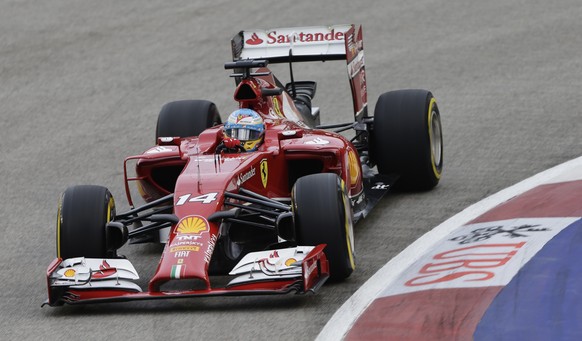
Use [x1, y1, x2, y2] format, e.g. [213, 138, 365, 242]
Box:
[224, 108, 265, 152]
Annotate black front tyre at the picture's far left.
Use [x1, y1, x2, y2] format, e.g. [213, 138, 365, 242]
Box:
[57, 185, 115, 259]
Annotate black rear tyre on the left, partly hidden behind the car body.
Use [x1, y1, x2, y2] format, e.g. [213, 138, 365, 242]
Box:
[156, 100, 222, 141]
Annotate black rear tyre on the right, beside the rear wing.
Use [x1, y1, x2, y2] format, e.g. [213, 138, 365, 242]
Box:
[370, 90, 443, 190]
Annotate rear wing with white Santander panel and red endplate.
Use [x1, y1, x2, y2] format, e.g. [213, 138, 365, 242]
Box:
[231, 25, 368, 120]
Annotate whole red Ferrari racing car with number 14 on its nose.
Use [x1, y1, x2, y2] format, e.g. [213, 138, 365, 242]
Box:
[46, 25, 442, 306]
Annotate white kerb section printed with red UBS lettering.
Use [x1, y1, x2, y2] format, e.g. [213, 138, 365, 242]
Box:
[381, 218, 578, 296]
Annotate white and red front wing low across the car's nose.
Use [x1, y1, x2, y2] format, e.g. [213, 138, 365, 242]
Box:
[43, 244, 329, 306]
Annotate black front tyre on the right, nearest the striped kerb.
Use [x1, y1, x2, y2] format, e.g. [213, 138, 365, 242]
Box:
[292, 173, 355, 281]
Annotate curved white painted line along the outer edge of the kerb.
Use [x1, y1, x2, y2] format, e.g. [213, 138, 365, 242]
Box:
[316, 157, 582, 341]
